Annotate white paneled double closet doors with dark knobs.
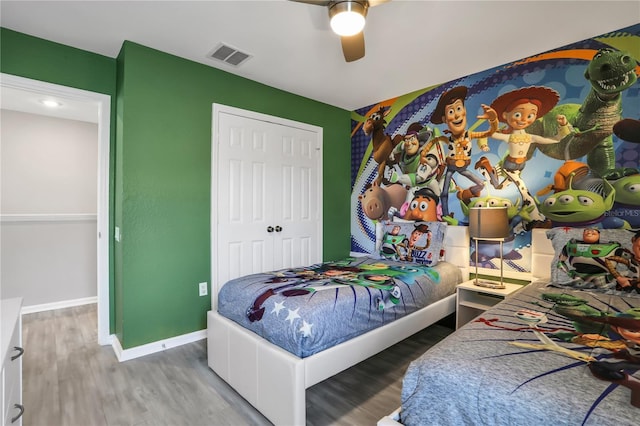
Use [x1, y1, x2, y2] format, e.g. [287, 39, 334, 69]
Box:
[211, 104, 322, 306]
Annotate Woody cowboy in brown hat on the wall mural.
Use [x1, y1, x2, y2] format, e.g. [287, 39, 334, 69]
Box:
[424, 86, 498, 219]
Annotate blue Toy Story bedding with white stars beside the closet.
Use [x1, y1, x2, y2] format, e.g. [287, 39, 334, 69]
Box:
[218, 257, 462, 358]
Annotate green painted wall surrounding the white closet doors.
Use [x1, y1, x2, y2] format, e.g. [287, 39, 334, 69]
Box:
[1, 29, 351, 349]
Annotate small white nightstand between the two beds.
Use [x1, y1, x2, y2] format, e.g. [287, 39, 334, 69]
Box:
[456, 279, 524, 329]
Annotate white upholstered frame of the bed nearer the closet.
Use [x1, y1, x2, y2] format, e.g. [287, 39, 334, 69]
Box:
[207, 226, 470, 425]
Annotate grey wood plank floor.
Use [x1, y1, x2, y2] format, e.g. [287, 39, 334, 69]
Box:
[22, 305, 452, 426]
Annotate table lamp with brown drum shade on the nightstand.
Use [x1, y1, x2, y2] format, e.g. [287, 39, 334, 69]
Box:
[469, 207, 510, 288]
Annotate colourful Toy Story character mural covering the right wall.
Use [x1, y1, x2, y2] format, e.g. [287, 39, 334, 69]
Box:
[351, 24, 640, 272]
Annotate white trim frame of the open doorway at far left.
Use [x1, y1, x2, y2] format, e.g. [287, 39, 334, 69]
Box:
[0, 73, 112, 345]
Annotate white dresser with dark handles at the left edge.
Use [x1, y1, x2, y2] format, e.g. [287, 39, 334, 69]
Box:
[0, 298, 24, 426]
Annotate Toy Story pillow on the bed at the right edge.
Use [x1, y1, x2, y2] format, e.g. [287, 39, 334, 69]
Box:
[547, 227, 640, 296]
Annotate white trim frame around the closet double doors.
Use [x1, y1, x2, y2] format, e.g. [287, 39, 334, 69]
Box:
[210, 103, 324, 311]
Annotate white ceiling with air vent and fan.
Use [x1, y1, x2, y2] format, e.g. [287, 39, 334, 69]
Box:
[0, 0, 640, 118]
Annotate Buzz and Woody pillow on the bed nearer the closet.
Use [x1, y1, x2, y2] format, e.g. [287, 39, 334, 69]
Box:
[378, 221, 447, 266]
